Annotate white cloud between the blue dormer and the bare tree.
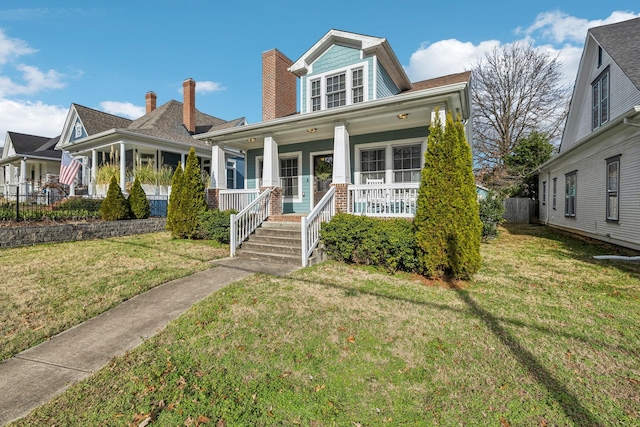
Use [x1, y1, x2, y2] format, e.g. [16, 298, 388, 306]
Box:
[405, 39, 500, 81]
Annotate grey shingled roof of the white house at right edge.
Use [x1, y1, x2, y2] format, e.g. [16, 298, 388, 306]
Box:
[589, 18, 640, 89]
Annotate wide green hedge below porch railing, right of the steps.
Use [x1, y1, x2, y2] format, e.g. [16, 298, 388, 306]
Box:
[320, 213, 418, 271]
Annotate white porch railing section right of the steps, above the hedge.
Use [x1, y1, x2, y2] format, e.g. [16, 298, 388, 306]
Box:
[347, 182, 420, 218]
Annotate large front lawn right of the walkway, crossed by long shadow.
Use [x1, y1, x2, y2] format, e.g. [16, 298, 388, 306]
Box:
[6, 226, 640, 426]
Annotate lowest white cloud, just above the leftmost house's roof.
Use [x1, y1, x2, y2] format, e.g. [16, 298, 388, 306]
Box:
[0, 99, 68, 138]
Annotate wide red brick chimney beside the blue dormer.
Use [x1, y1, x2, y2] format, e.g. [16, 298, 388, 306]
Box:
[262, 49, 297, 121]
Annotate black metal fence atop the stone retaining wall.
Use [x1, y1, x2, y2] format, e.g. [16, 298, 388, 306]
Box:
[0, 191, 168, 221]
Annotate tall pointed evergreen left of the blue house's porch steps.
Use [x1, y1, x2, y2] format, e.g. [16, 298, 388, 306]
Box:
[171, 147, 206, 239]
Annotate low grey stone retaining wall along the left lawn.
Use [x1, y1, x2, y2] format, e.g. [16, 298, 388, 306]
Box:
[0, 218, 167, 248]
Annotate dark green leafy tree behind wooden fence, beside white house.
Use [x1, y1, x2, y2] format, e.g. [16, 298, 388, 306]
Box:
[504, 131, 554, 199]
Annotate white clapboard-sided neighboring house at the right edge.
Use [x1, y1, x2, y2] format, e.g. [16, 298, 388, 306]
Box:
[538, 18, 640, 249]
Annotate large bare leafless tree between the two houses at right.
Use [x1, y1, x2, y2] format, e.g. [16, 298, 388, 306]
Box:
[471, 42, 570, 189]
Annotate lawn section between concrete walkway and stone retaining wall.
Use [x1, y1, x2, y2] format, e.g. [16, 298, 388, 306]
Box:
[0, 233, 229, 362]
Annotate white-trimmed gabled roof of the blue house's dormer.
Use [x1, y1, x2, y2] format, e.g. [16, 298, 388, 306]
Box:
[289, 30, 411, 91]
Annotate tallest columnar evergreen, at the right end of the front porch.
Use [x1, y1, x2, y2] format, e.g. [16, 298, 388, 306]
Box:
[414, 115, 482, 279]
